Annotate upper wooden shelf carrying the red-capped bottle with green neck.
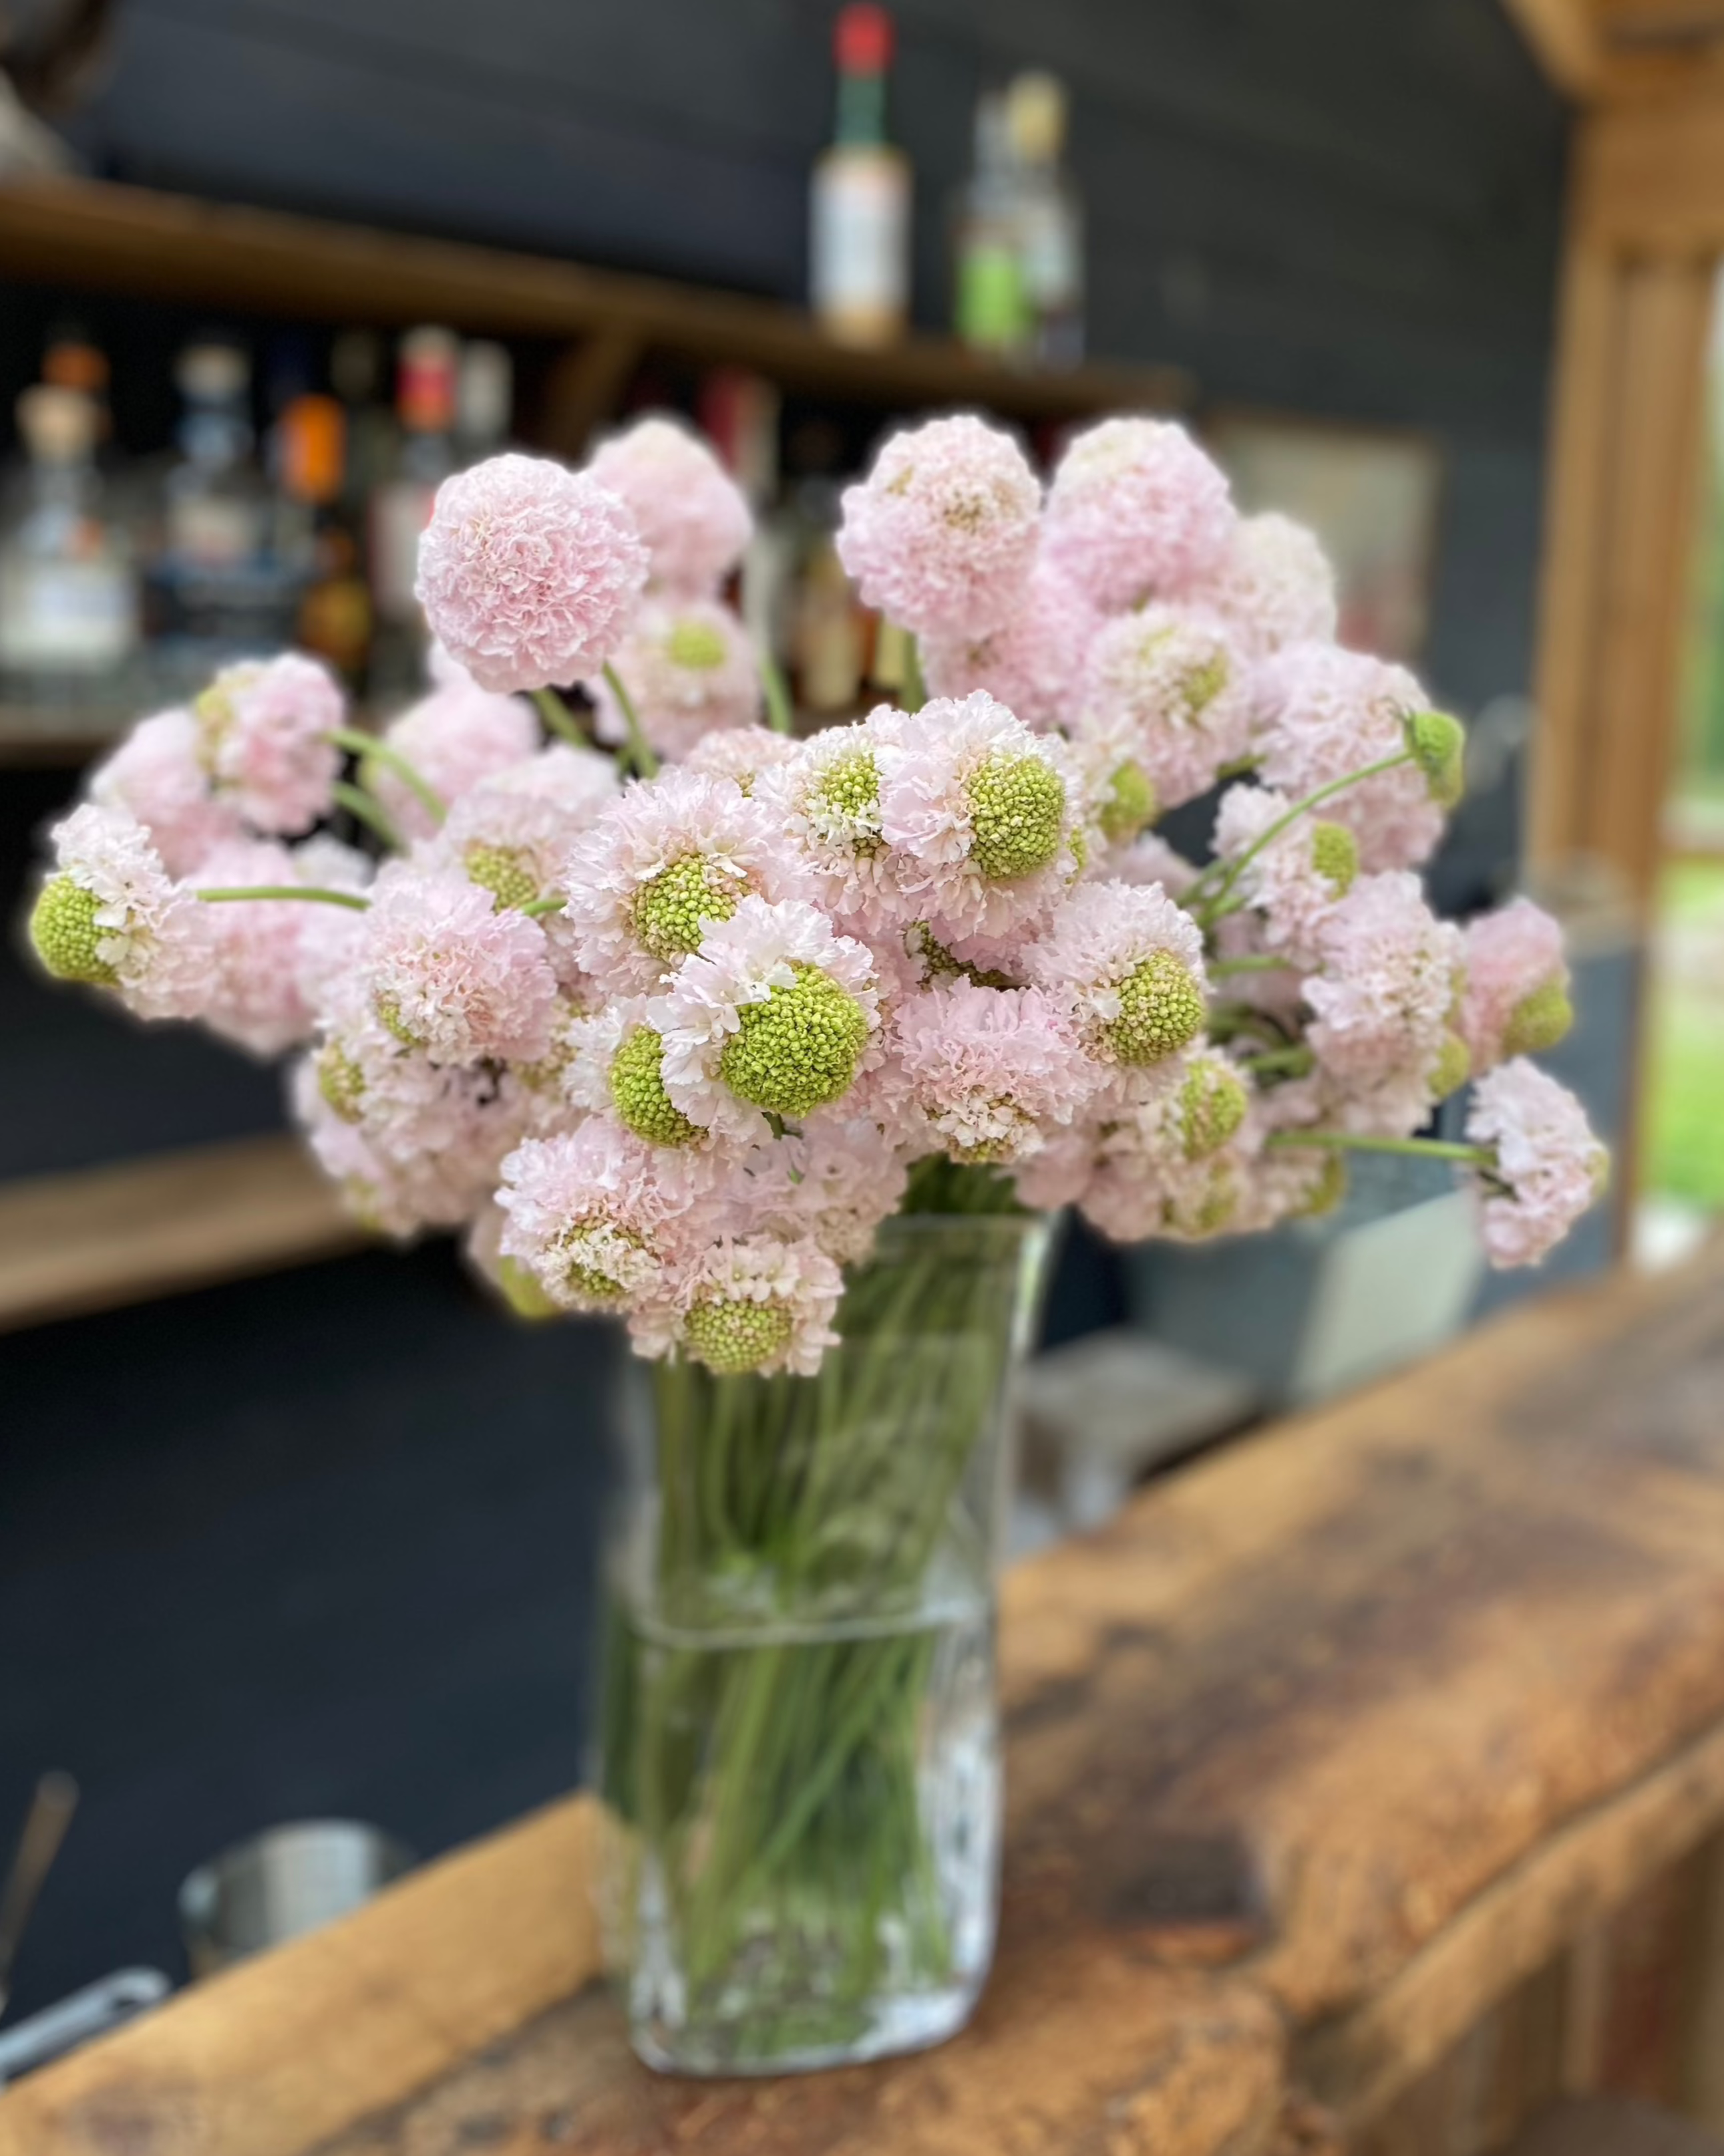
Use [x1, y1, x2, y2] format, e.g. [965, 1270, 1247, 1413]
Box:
[0, 179, 1192, 446]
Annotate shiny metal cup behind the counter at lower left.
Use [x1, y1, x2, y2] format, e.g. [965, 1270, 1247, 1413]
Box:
[179, 1820, 413, 1977]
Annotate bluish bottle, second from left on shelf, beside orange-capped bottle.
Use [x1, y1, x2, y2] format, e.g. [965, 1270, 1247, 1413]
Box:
[144, 339, 302, 701]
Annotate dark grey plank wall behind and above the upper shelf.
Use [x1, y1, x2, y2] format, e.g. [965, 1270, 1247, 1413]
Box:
[67, 0, 1562, 733]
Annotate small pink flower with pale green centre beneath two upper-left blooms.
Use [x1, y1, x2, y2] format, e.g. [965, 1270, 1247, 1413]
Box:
[586, 599, 761, 763]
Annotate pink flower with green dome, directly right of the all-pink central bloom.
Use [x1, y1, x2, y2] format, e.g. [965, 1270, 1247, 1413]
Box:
[1023, 882, 1207, 1074]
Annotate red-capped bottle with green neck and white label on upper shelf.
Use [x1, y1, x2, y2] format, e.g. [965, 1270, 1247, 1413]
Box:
[810, 4, 909, 345]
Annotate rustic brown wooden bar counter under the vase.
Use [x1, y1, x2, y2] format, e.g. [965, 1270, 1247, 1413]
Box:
[0, 1248, 1724, 2156]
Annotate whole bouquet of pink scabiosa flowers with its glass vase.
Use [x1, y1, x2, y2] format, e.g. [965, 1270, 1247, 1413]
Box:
[32, 418, 1603, 2072]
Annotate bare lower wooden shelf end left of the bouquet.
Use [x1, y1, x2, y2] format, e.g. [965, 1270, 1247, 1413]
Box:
[0, 1136, 364, 1332]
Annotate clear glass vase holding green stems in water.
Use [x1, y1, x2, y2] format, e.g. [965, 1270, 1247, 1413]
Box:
[594, 1214, 1047, 2074]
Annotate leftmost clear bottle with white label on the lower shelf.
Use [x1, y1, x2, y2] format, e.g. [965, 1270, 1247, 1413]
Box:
[0, 383, 138, 707]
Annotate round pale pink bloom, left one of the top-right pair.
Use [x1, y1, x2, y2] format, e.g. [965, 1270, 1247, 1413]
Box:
[838, 416, 1041, 638]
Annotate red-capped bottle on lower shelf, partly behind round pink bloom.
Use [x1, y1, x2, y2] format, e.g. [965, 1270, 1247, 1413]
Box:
[371, 328, 461, 696]
